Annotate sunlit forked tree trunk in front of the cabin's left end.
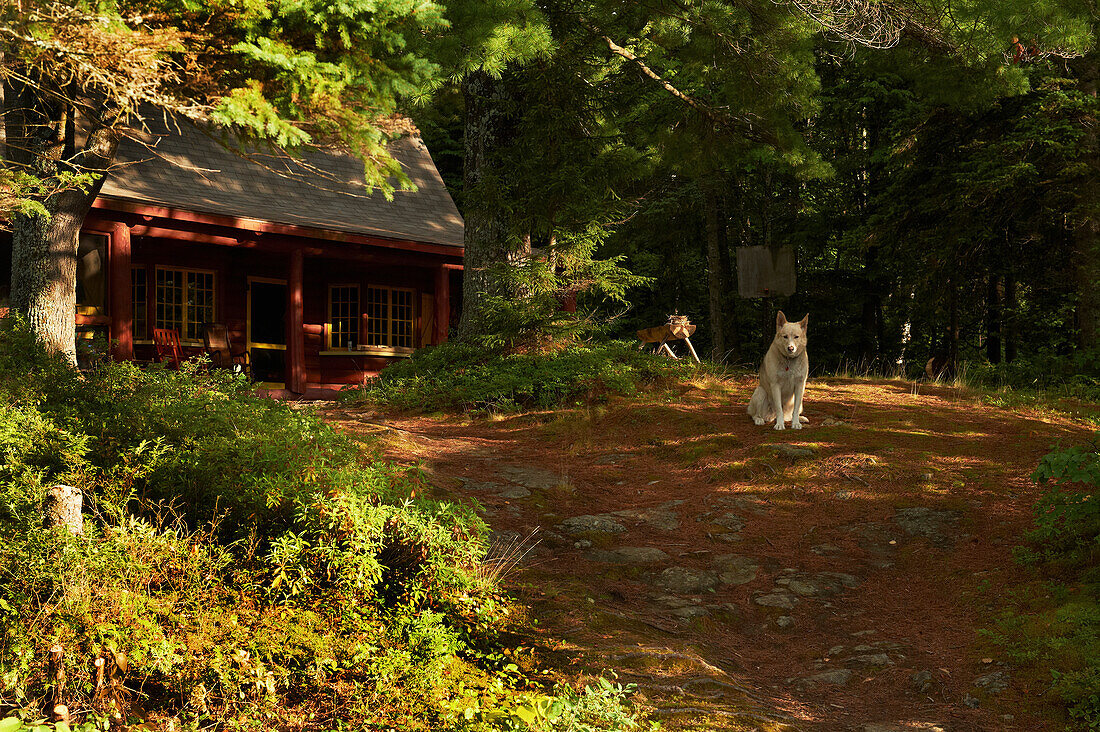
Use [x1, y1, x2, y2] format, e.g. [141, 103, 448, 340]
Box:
[4, 82, 119, 365]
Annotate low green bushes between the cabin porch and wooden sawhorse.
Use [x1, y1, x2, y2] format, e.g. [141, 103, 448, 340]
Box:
[344, 341, 692, 412]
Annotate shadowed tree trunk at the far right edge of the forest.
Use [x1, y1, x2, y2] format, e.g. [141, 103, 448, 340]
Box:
[1071, 52, 1100, 348]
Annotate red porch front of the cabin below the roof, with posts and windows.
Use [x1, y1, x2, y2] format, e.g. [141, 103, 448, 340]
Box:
[77, 198, 462, 398]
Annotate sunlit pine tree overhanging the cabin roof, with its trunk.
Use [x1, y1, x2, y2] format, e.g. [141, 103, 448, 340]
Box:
[0, 0, 446, 363]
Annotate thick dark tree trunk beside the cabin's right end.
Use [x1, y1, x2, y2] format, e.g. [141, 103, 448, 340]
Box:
[458, 72, 516, 340]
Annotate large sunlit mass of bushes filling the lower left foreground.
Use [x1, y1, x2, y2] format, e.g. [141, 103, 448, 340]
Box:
[0, 318, 638, 732]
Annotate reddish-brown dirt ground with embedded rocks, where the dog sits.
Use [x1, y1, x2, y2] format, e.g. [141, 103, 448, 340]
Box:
[328, 378, 1092, 732]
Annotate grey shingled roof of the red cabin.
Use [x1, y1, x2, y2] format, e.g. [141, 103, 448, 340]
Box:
[100, 121, 463, 247]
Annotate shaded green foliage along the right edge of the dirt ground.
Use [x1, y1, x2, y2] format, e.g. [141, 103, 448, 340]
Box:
[993, 436, 1100, 730]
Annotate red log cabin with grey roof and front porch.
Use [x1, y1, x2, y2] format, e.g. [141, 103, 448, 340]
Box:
[0, 122, 463, 397]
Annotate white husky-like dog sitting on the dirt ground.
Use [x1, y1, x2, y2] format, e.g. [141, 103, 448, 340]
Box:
[748, 310, 810, 429]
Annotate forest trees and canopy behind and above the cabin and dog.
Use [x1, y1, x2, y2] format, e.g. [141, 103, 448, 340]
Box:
[0, 0, 1100, 370]
